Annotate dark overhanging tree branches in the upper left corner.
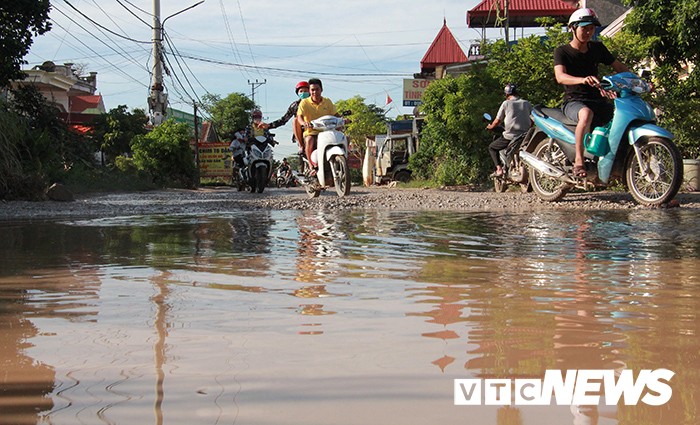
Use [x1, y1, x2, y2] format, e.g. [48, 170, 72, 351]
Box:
[0, 0, 51, 87]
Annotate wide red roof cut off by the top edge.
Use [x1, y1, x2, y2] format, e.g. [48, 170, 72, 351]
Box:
[467, 0, 577, 28]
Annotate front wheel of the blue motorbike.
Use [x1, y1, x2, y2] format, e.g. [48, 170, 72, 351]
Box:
[625, 137, 683, 205]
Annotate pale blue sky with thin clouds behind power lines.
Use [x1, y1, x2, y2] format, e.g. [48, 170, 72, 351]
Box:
[25, 0, 501, 159]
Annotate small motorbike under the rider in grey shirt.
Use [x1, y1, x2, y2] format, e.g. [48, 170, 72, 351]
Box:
[484, 113, 532, 193]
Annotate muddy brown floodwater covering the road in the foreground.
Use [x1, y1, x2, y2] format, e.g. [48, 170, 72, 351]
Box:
[0, 209, 700, 425]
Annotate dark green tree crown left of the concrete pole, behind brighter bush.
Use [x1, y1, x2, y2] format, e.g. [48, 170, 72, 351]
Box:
[92, 105, 148, 165]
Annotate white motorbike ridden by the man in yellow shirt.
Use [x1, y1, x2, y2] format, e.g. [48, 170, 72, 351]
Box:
[294, 115, 350, 198]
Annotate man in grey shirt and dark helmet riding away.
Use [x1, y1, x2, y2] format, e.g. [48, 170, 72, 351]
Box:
[486, 83, 532, 177]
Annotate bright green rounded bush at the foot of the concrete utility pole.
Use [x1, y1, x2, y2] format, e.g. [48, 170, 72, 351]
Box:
[131, 119, 197, 187]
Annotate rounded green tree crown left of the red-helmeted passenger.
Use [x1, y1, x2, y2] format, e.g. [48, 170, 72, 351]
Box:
[202, 93, 255, 140]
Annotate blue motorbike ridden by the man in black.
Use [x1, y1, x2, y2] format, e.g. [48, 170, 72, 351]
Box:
[520, 72, 683, 206]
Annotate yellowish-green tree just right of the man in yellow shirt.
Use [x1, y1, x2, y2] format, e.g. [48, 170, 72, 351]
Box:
[335, 96, 387, 156]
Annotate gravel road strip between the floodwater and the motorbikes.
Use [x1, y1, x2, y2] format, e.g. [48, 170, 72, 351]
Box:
[0, 186, 700, 220]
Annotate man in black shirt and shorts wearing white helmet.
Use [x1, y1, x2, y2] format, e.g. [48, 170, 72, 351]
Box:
[554, 8, 628, 178]
